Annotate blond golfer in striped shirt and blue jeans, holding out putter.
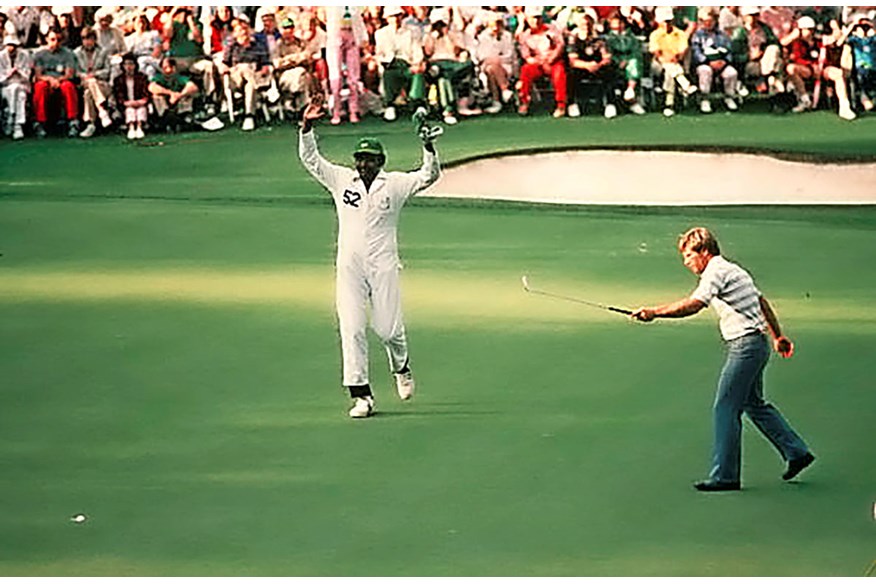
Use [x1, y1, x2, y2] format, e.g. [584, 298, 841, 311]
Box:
[632, 227, 815, 491]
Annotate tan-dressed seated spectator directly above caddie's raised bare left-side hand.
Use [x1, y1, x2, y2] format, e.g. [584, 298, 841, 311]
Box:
[272, 19, 319, 112]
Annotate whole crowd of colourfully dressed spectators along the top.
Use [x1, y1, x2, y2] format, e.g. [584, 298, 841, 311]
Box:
[0, 6, 876, 140]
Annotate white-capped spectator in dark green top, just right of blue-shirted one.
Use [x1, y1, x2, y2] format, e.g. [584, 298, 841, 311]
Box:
[731, 6, 784, 93]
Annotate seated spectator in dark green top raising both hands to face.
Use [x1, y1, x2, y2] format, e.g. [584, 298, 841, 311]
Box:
[163, 6, 219, 115]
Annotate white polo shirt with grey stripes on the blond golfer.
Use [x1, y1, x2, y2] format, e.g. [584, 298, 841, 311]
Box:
[690, 256, 766, 341]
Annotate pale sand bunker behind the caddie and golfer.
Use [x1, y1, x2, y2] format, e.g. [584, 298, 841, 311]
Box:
[424, 150, 876, 205]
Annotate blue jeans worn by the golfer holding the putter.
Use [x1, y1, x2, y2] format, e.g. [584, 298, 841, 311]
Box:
[709, 334, 809, 482]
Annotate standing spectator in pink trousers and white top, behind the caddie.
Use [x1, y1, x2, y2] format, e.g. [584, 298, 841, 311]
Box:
[325, 5, 368, 126]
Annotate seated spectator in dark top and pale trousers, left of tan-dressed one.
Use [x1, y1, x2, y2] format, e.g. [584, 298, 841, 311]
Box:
[219, 15, 271, 132]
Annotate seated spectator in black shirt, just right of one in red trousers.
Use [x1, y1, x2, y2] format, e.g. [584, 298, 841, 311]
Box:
[566, 13, 620, 119]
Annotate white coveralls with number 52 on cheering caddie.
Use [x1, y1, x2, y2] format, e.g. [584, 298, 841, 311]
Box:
[298, 131, 441, 387]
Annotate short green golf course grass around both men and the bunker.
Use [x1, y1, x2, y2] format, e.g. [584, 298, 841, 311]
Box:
[0, 113, 876, 576]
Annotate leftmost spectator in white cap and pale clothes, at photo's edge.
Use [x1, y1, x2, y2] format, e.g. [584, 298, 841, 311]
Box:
[0, 31, 33, 140]
